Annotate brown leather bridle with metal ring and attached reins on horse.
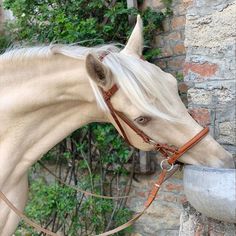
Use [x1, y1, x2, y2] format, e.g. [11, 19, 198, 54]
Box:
[0, 55, 209, 236]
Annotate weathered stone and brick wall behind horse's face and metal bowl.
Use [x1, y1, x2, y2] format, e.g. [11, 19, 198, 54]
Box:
[130, 0, 236, 236]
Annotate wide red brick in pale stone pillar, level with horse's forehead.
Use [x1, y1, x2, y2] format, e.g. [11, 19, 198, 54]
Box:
[184, 62, 218, 77]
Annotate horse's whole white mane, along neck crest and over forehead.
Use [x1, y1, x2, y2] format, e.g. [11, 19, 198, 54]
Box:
[0, 45, 176, 121]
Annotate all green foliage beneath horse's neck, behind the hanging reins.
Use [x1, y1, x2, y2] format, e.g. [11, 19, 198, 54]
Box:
[16, 124, 133, 236]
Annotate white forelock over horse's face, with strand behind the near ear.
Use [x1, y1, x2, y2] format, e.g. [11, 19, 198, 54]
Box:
[95, 52, 179, 122]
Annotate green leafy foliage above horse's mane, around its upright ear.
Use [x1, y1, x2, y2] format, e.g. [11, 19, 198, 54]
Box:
[4, 0, 169, 60]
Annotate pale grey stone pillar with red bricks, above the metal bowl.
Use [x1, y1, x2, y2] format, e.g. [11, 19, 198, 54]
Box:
[184, 0, 236, 157]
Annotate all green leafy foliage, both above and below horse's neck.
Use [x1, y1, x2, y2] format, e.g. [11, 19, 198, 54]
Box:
[3, 0, 170, 236]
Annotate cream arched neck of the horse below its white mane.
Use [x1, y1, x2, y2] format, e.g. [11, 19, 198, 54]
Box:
[0, 55, 106, 183]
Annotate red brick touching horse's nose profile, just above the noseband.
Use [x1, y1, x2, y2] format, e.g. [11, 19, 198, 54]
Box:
[188, 108, 210, 127]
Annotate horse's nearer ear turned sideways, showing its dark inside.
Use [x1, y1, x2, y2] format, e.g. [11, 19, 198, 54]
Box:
[85, 53, 112, 88]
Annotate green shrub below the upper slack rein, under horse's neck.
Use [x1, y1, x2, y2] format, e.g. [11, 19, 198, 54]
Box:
[16, 179, 131, 236]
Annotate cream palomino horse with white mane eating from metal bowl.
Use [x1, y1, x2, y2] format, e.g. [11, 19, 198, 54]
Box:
[0, 17, 234, 236]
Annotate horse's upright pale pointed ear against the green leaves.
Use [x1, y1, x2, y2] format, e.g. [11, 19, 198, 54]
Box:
[121, 15, 143, 57]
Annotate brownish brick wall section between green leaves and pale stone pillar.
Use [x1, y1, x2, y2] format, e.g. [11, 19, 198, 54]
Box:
[145, 0, 191, 76]
